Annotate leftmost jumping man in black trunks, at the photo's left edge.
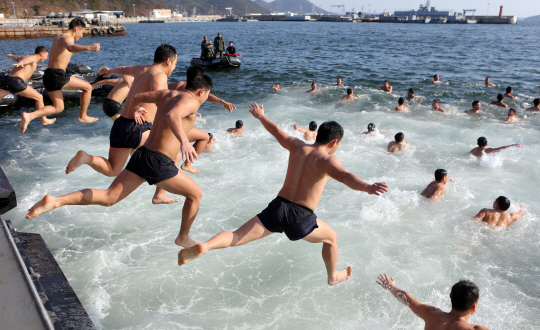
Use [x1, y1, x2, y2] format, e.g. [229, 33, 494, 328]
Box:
[0, 46, 56, 133]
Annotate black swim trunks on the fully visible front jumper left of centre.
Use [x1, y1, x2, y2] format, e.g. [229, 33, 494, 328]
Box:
[126, 146, 178, 184]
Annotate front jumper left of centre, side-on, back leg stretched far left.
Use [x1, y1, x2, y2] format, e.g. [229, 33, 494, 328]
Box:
[26, 73, 213, 247]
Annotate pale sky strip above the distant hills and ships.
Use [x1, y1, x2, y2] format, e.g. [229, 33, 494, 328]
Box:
[302, 0, 540, 17]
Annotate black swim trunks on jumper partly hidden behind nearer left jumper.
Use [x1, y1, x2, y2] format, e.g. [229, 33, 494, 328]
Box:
[109, 116, 152, 149]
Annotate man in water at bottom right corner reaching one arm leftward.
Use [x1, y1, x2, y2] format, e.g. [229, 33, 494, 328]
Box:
[376, 274, 489, 330]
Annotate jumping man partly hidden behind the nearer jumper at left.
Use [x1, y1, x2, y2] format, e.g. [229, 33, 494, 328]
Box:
[66, 44, 179, 204]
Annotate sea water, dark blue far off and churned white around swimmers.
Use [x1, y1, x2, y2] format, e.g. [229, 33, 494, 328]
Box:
[0, 22, 540, 329]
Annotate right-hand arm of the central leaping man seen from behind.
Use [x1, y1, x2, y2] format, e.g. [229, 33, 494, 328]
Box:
[324, 156, 388, 196]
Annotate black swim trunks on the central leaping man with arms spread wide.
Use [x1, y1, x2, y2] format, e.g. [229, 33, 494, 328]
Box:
[257, 196, 319, 241]
